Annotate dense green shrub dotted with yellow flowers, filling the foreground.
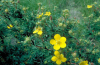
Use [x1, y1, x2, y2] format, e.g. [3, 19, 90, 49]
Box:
[0, 0, 100, 65]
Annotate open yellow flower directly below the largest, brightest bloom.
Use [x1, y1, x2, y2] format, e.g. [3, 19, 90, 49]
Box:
[51, 51, 67, 65]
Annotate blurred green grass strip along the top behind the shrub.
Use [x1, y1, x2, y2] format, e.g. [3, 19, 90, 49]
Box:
[20, 0, 100, 16]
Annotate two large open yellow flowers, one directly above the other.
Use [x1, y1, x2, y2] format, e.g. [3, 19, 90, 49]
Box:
[50, 34, 67, 65]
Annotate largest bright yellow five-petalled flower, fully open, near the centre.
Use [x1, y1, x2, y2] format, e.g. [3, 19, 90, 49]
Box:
[50, 34, 66, 50]
